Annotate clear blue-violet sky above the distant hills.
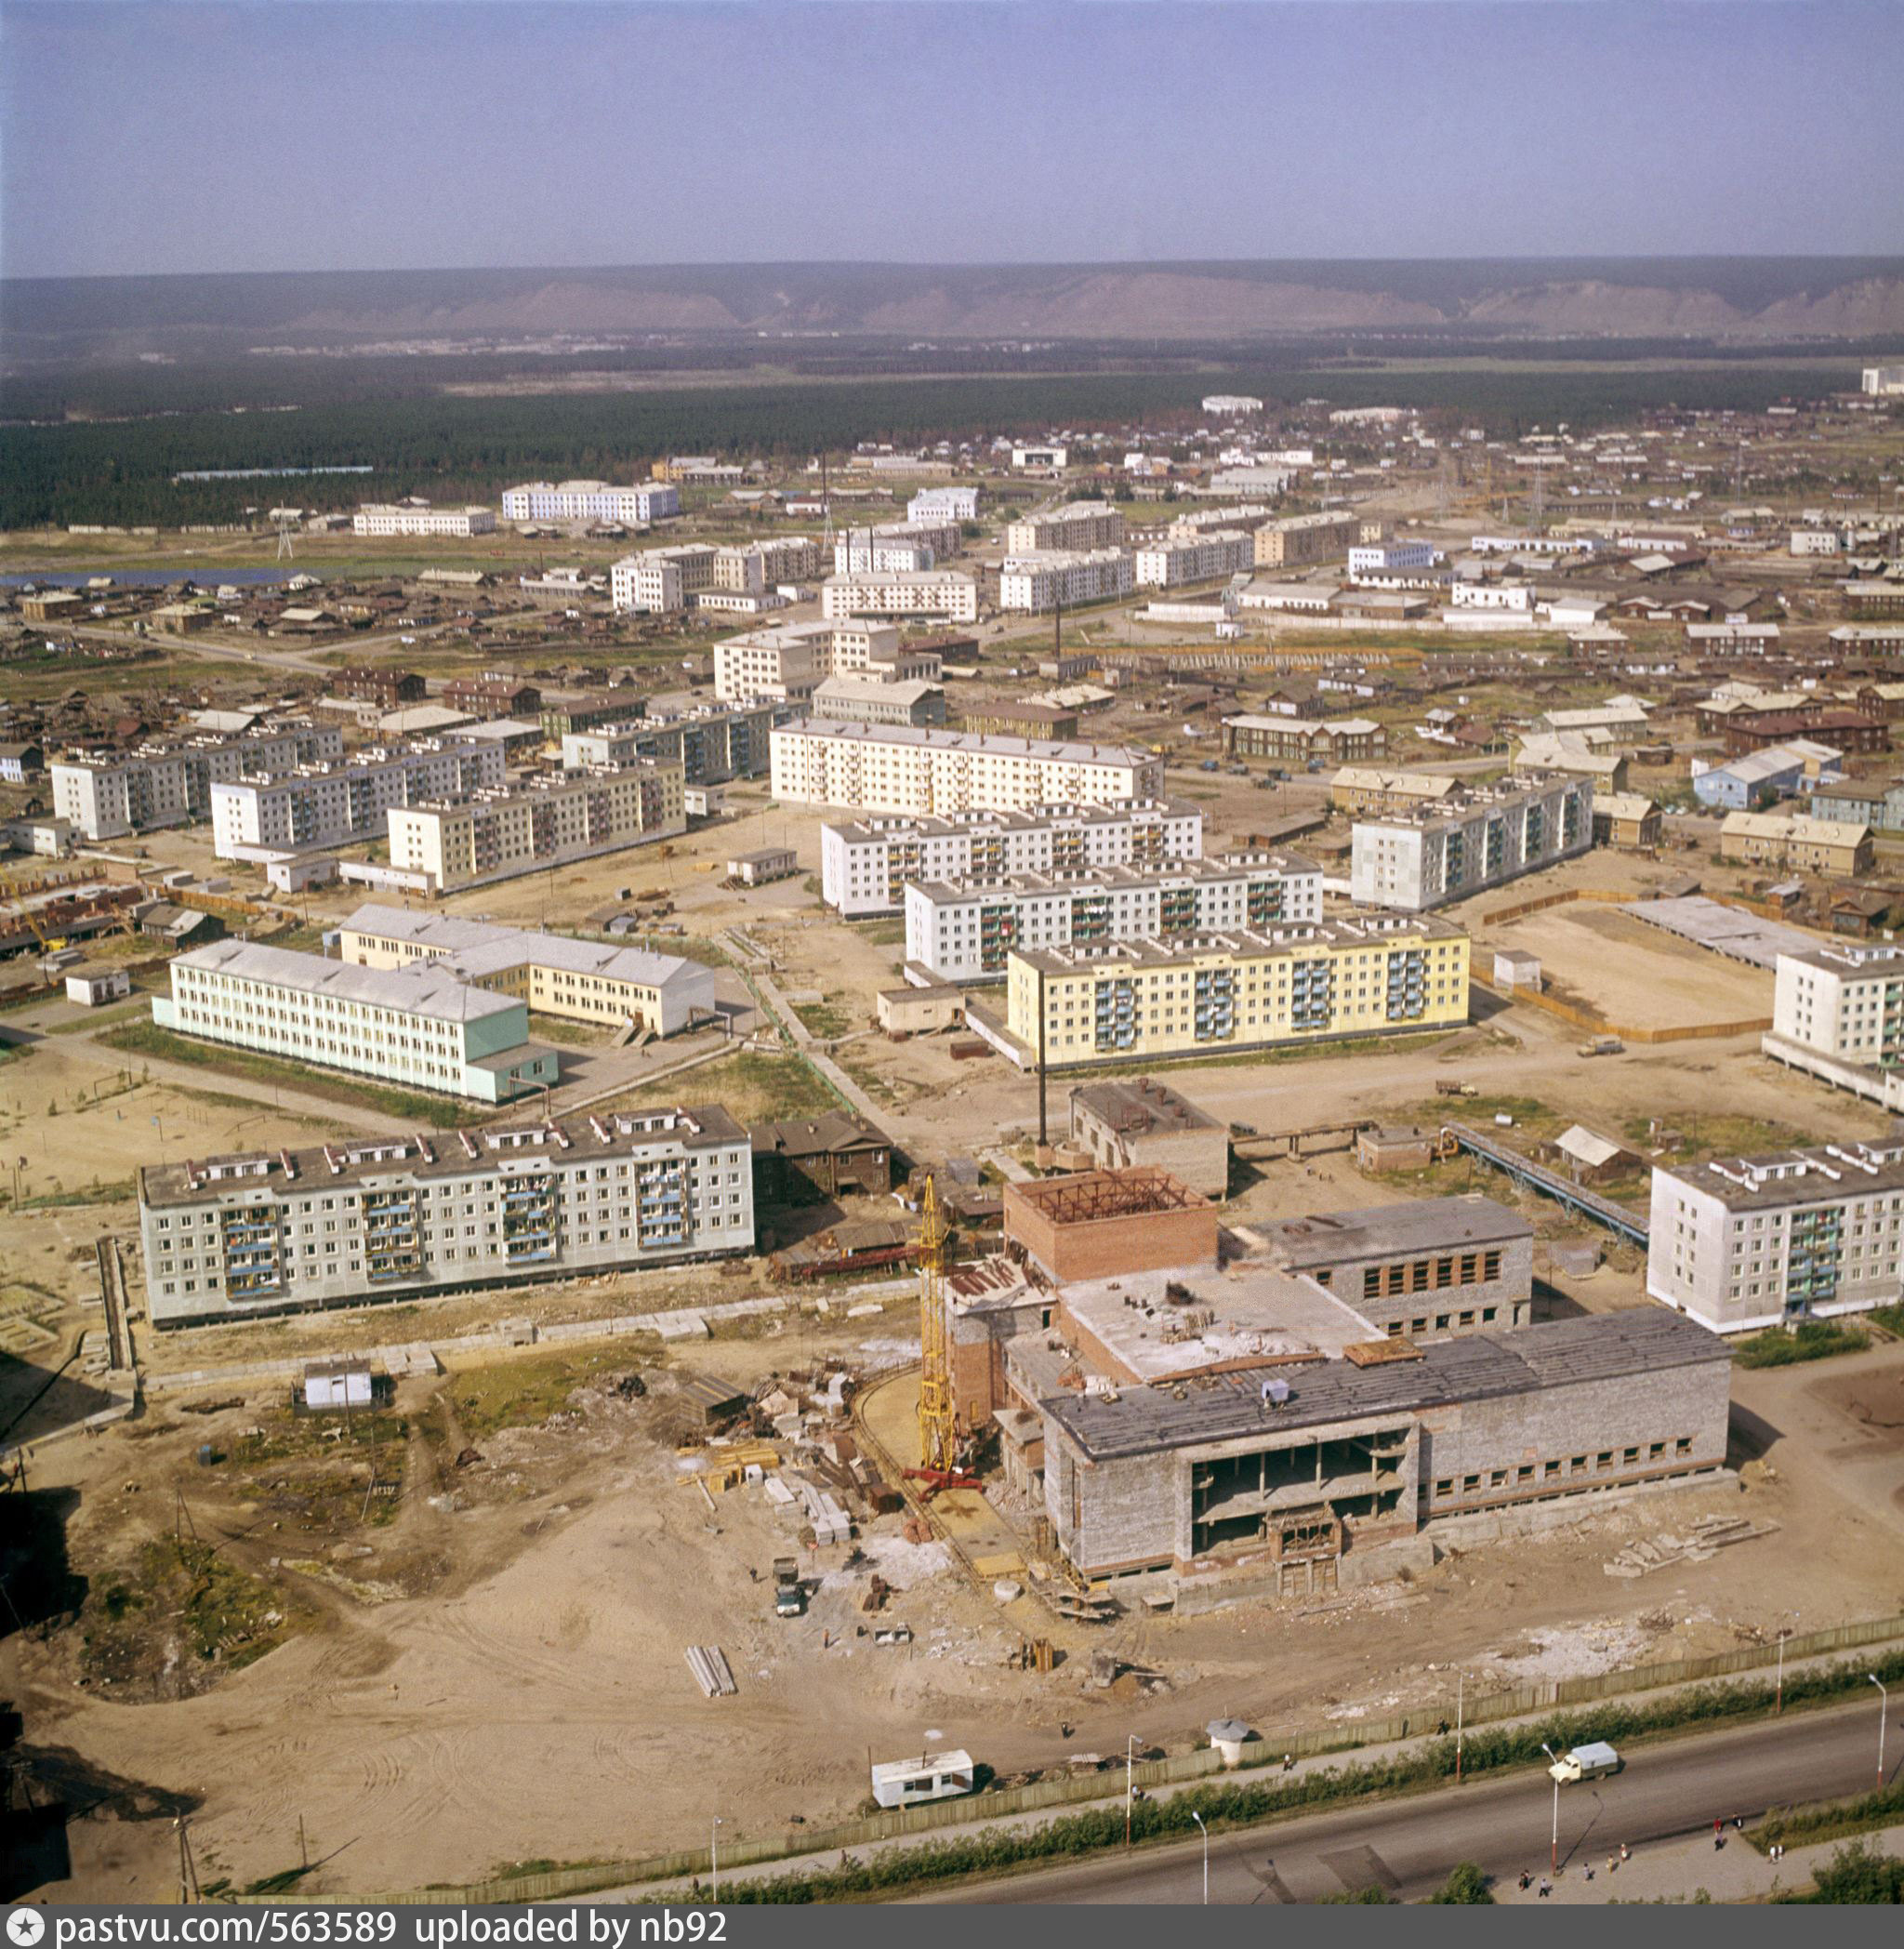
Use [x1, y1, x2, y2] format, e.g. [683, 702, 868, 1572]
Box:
[0, 0, 1904, 277]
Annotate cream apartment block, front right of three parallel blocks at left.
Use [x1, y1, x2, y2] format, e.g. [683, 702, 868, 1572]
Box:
[386, 758, 688, 893]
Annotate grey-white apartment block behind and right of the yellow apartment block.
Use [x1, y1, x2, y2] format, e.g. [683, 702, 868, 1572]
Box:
[1349, 776, 1594, 914]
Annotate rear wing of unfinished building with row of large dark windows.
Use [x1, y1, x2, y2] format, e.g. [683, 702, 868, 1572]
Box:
[1251, 1193, 1534, 1341]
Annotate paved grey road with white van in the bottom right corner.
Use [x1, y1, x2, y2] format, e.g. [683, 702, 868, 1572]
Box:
[930, 1691, 1904, 1903]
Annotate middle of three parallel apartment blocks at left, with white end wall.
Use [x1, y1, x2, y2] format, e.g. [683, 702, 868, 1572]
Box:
[212, 738, 505, 859]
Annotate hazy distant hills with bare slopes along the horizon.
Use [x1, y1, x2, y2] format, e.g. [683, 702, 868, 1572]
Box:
[0, 258, 1904, 352]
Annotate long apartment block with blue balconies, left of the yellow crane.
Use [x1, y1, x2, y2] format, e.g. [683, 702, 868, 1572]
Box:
[139, 1105, 754, 1329]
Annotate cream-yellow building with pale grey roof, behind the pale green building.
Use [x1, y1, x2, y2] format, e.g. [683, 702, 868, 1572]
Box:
[337, 902, 715, 1035]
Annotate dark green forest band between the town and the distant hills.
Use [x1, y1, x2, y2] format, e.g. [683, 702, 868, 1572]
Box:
[0, 361, 1858, 528]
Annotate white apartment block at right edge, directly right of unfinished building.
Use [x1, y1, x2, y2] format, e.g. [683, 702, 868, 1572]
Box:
[1646, 1142, 1904, 1333]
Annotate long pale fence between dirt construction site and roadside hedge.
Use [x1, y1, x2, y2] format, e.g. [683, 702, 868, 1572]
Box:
[234, 1616, 1904, 1906]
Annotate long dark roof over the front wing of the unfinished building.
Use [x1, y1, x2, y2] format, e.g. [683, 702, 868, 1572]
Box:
[1038, 1306, 1733, 1462]
